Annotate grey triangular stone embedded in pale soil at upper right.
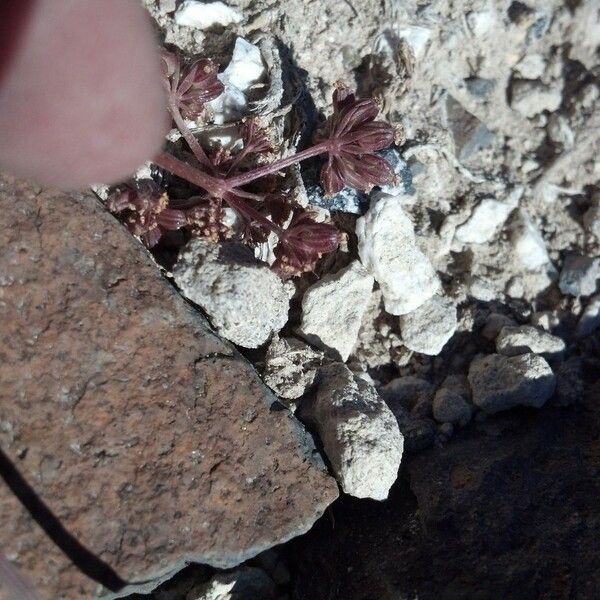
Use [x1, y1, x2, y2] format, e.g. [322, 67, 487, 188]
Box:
[442, 94, 494, 161]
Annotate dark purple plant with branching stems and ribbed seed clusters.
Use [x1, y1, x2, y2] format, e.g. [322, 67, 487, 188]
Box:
[108, 53, 394, 277]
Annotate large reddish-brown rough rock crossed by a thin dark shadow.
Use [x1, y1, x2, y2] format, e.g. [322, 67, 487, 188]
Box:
[0, 177, 337, 600]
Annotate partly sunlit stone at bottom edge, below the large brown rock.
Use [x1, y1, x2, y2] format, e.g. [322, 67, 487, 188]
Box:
[189, 567, 276, 600]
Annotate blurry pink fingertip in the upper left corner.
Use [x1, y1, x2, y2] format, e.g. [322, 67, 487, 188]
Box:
[0, 0, 169, 189]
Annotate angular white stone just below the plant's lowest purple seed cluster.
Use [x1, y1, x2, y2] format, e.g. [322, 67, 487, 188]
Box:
[298, 260, 373, 361]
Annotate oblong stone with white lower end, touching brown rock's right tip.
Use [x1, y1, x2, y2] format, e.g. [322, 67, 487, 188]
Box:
[300, 363, 403, 500]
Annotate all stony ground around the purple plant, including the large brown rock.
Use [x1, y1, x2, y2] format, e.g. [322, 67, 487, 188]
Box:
[0, 0, 600, 600]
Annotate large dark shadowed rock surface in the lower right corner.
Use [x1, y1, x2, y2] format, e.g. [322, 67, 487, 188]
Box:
[283, 385, 600, 600]
